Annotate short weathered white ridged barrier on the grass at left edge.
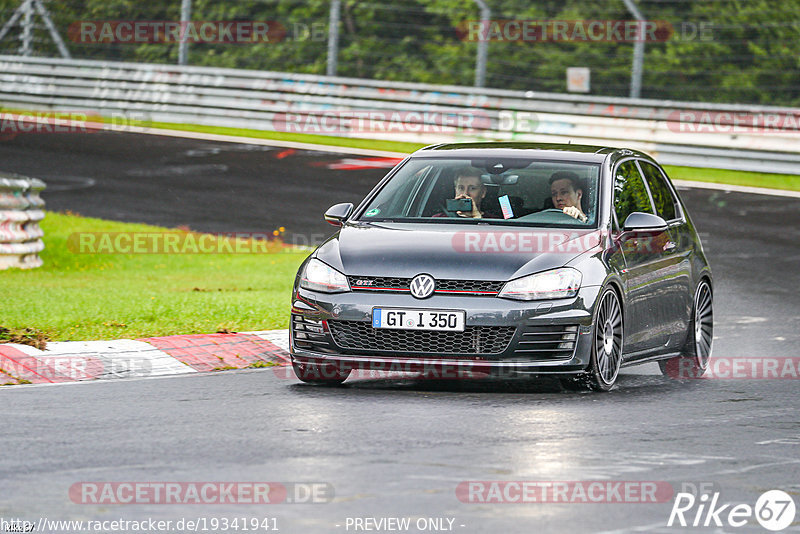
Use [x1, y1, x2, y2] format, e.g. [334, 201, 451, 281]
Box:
[0, 174, 45, 270]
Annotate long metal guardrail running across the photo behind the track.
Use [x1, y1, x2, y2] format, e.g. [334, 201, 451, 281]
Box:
[0, 56, 800, 174]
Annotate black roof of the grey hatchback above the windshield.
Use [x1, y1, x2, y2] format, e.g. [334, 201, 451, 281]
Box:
[413, 142, 652, 163]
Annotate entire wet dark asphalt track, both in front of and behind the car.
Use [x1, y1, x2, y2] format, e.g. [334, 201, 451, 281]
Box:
[0, 134, 800, 533]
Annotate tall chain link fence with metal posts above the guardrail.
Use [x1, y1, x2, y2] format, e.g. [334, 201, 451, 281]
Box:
[0, 0, 800, 106]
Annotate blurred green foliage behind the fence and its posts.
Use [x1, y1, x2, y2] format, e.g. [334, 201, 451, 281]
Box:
[0, 0, 800, 105]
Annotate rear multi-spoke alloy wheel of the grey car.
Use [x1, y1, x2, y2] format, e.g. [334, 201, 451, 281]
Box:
[658, 280, 714, 378]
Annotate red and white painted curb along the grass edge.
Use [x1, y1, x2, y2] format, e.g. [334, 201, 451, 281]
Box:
[0, 330, 290, 385]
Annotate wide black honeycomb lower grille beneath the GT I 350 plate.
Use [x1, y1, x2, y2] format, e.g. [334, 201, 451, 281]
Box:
[328, 321, 516, 354]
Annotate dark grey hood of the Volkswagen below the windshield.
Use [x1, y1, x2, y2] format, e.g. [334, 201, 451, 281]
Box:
[317, 223, 599, 280]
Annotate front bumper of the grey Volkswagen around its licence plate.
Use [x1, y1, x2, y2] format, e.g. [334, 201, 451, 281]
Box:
[290, 286, 600, 378]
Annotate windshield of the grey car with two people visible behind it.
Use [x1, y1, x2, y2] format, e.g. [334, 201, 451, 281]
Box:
[358, 158, 600, 227]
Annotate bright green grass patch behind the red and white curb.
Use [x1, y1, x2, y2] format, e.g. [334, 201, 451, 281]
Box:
[0, 212, 308, 341]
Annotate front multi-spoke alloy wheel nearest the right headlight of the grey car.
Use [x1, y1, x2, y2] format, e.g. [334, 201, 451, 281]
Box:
[583, 288, 624, 391]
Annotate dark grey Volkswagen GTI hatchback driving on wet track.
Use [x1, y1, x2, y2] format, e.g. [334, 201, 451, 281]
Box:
[290, 143, 713, 391]
